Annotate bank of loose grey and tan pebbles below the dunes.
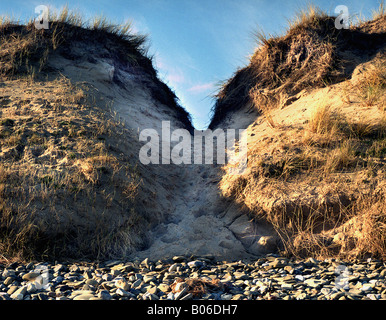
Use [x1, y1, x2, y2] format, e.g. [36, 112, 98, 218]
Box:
[0, 255, 386, 300]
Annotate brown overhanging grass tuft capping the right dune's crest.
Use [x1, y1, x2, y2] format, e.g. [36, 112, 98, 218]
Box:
[209, 6, 385, 128]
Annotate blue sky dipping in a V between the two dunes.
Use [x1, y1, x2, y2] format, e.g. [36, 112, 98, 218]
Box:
[0, 0, 379, 129]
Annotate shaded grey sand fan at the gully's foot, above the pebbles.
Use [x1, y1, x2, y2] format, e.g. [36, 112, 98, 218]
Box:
[133, 165, 278, 259]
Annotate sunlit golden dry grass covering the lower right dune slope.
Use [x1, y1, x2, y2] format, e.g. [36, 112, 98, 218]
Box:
[220, 86, 386, 256]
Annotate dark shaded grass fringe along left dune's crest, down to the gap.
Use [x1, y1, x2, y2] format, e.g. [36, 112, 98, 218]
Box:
[0, 7, 193, 131]
